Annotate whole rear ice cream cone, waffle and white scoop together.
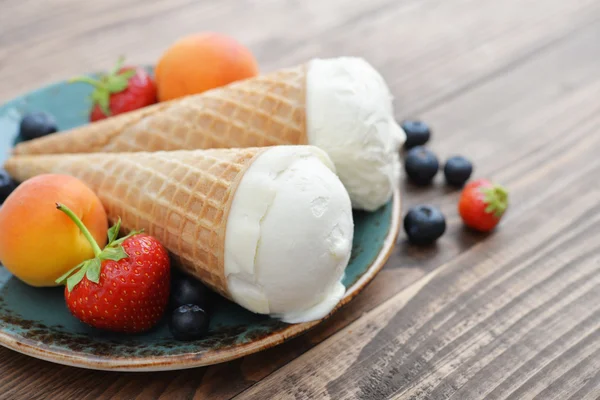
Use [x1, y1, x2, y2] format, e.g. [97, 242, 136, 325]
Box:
[14, 57, 405, 211]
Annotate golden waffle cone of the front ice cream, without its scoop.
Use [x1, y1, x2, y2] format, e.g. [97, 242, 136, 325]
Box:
[5, 148, 265, 296]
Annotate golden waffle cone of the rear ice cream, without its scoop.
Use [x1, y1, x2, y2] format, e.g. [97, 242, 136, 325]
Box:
[14, 65, 307, 154]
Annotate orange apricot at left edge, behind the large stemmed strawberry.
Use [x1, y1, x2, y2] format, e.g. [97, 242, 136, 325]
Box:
[0, 174, 108, 286]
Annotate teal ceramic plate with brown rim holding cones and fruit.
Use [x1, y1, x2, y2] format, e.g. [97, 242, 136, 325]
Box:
[0, 76, 400, 371]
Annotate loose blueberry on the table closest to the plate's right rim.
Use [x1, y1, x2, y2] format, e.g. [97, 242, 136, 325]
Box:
[404, 205, 446, 245]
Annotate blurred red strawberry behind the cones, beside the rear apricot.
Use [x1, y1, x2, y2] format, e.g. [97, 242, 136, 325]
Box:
[70, 58, 156, 122]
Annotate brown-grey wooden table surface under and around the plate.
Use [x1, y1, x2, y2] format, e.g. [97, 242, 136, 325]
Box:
[0, 0, 600, 400]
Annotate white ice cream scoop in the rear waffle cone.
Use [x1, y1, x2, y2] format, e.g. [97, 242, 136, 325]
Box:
[306, 57, 406, 211]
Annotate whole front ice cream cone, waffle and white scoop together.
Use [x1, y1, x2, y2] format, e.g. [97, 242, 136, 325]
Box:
[5, 146, 354, 323]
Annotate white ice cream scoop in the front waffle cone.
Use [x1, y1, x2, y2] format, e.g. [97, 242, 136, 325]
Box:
[225, 146, 354, 323]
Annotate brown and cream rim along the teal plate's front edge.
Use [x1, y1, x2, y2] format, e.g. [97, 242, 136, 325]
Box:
[0, 188, 401, 372]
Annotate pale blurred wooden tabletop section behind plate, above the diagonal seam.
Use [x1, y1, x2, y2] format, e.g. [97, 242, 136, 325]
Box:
[0, 0, 600, 116]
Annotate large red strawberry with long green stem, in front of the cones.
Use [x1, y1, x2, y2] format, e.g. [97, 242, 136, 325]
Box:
[56, 204, 171, 333]
